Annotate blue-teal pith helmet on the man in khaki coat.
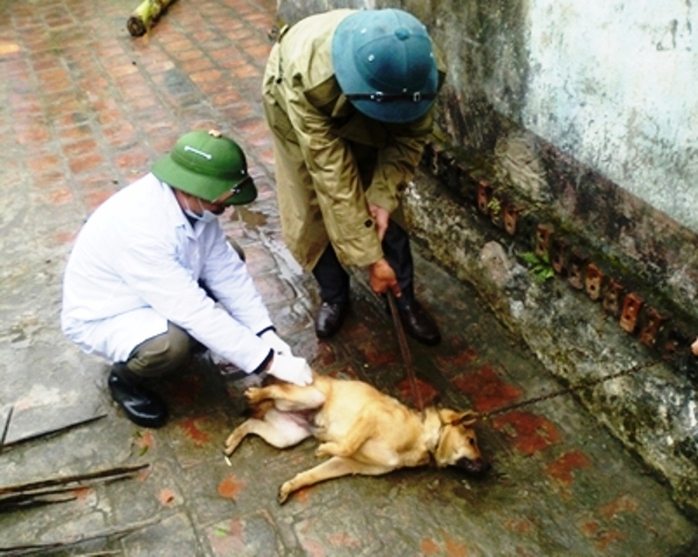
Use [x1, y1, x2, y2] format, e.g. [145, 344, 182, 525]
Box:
[332, 8, 439, 123]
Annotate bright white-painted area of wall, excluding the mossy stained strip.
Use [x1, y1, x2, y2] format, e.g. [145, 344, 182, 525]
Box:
[517, 0, 698, 232]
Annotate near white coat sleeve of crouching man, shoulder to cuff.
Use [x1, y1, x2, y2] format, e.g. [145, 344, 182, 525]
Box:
[114, 226, 270, 373]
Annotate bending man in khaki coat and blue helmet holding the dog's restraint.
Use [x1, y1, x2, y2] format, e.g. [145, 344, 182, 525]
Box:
[263, 9, 443, 345]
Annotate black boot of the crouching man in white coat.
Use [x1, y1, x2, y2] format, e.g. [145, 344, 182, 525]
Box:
[107, 370, 167, 428]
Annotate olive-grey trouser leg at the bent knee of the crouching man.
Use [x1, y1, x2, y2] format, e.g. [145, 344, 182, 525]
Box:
[125, 323, 193, 379]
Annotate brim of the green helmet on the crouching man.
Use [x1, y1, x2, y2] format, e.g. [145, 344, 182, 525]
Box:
[151, 154, 257, 205]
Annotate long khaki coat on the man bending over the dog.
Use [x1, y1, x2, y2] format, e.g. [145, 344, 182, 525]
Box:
[262, 10, 443, 270]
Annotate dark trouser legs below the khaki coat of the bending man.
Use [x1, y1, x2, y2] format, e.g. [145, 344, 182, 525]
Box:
[313, 220, 414, 305]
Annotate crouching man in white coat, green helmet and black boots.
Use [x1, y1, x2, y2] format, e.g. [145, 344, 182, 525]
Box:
[61, 131, 312, 427]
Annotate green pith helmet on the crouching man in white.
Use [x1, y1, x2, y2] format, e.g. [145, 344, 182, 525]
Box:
[151, 130, 257, 205]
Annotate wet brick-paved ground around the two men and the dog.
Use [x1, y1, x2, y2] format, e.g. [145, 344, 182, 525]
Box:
[0, 0, 698, 557]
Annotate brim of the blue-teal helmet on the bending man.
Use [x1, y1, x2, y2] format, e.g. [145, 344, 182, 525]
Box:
[332, 10, 439, 124]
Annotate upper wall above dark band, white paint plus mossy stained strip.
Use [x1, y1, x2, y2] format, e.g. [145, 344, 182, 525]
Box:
[422, 0, 698, 228]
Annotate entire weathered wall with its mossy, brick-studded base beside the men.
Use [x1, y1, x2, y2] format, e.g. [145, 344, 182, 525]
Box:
[279, 0, 698, 511]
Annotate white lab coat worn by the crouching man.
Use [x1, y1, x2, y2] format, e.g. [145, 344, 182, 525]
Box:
[61, 174, 272, 373]
